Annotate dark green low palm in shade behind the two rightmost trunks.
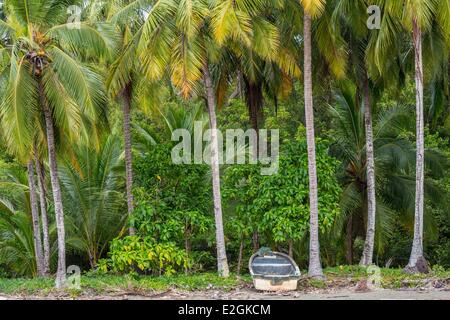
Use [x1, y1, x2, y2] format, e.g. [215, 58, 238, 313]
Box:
[330, 84, 446, 264]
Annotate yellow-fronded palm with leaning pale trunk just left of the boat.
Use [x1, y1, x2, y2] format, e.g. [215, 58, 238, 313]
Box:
[110, 0, 282, 277]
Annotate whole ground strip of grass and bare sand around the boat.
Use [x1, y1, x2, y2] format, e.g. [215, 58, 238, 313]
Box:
[0, 267, 450, 300]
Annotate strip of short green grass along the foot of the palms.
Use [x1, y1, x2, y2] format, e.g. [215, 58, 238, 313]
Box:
[0, 266, 450, 298]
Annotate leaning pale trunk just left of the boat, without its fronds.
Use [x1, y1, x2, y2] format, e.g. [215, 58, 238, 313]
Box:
[203, 62, 230, 277]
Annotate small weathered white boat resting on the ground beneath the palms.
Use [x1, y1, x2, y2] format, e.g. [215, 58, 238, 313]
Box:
[249, 248, 300, 291]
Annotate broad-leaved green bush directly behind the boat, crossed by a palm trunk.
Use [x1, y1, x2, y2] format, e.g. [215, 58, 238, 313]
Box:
[224, 138, 341, 244]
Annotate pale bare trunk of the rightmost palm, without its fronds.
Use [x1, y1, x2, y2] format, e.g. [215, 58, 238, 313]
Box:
[405, 19, 425, 273]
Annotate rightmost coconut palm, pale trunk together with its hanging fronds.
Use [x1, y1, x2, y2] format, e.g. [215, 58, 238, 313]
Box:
[372, 0, 450, 273]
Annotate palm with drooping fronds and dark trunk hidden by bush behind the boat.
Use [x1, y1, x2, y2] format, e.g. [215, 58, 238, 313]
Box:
[207, 0, 300, 252]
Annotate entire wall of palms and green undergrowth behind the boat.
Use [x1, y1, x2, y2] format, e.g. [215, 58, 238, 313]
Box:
[0, 0, 450, 288]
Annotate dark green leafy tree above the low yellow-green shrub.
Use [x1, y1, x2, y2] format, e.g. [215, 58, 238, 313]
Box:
[130, 143, 212, 243]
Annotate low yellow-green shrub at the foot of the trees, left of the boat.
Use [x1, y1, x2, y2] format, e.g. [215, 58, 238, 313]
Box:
[98, 236, 188, 275]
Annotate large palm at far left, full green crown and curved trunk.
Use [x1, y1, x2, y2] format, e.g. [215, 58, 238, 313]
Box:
[0, 0, 115, 288]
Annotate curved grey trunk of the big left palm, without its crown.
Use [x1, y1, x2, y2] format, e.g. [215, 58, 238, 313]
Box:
[39, 83, 66, 288]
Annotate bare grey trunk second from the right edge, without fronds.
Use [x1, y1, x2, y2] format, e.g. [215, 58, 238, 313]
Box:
[360, 76, 376, 266]
